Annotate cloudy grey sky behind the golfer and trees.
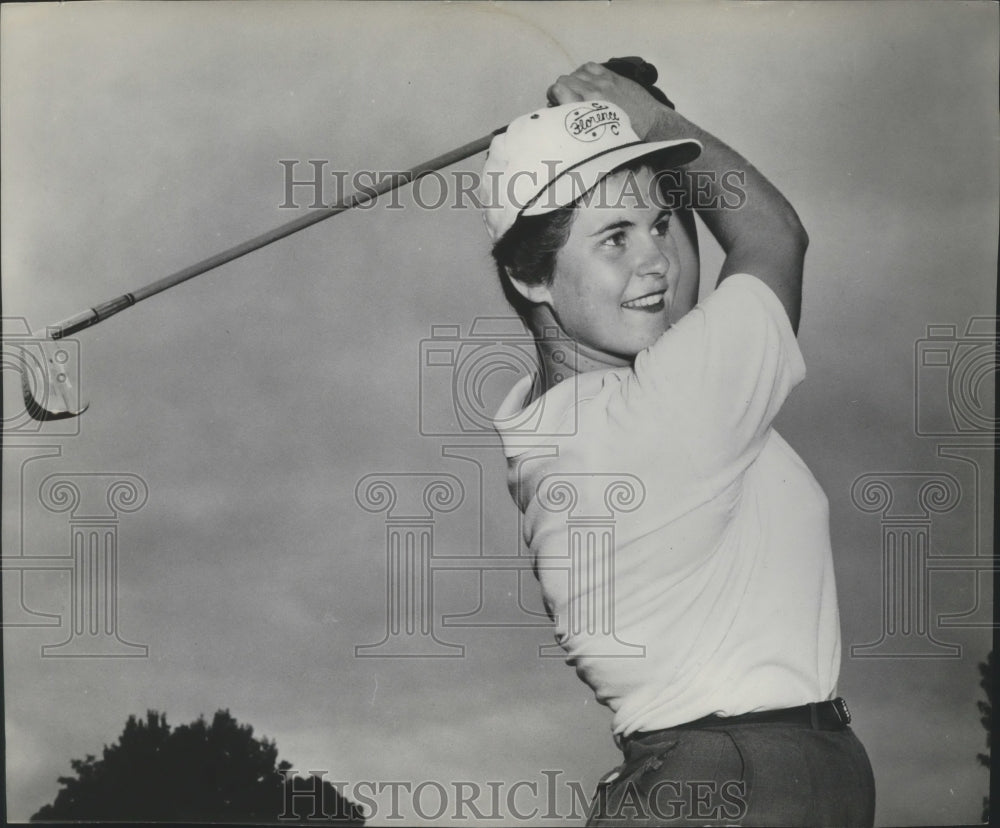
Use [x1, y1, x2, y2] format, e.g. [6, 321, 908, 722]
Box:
[0, 2, 998, 825]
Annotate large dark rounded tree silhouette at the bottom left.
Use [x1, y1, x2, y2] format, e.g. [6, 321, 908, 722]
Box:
[31, 710, 364, 826]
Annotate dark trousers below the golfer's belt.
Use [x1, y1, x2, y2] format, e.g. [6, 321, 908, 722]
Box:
[587, 723, 875, 828]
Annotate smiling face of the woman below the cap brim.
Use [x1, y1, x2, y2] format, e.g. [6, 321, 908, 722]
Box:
[535, 168, 690, 358]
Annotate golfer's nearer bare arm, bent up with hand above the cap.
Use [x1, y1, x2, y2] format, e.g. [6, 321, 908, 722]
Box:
[548, 63, 809, 331]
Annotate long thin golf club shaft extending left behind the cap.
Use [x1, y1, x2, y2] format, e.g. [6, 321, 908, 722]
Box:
[48, 127, 507, 339]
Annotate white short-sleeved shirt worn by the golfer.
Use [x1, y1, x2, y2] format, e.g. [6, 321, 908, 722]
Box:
[496, 274, 840, 735]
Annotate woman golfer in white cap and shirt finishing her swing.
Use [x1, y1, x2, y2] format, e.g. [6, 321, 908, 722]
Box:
[481, 63, 874, 826]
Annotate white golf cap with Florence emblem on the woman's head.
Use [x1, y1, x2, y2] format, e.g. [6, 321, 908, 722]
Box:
[479, 101, 701, 242]
